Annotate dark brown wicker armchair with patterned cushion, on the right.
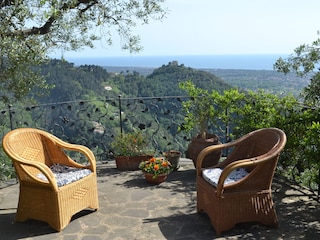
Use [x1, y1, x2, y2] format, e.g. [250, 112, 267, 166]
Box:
[196, 128, 286, 235]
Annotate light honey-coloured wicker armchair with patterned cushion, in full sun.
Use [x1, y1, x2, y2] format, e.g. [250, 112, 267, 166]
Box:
[2, 128, 99, 231]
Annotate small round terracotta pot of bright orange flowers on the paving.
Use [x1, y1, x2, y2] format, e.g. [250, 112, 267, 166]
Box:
[139, 157, 173, 184]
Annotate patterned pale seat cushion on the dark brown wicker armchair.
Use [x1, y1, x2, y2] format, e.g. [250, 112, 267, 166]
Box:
[202, 168, 248, 187]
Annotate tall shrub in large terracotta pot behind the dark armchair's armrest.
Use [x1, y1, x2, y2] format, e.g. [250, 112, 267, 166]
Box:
[179, 81, 221, 167]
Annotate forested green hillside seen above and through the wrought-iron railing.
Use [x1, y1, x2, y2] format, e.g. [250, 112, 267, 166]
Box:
[7, 60, 312, 162]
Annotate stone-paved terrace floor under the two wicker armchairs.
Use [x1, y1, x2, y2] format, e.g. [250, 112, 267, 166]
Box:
[0, 159, 320, 240]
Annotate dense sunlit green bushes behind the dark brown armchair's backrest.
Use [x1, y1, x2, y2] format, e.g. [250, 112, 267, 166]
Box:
[233, 91, 320, 194]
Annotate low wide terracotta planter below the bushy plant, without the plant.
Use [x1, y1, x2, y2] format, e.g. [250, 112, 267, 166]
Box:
[115, 155, 153, 171]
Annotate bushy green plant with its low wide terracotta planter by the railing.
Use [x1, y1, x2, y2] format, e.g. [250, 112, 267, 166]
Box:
[111, 131, 153, 171]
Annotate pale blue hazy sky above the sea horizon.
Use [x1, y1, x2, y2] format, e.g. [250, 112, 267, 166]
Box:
[52, 0, 320, 57]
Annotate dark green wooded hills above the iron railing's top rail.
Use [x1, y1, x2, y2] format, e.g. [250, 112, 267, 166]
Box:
[37, 60, 230, 103]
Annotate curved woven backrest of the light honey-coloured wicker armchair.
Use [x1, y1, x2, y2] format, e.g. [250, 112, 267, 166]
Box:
[2, 128, 67, 180]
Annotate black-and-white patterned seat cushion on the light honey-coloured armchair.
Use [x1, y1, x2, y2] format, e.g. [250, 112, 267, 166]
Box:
[37, 164, 91, 187]
